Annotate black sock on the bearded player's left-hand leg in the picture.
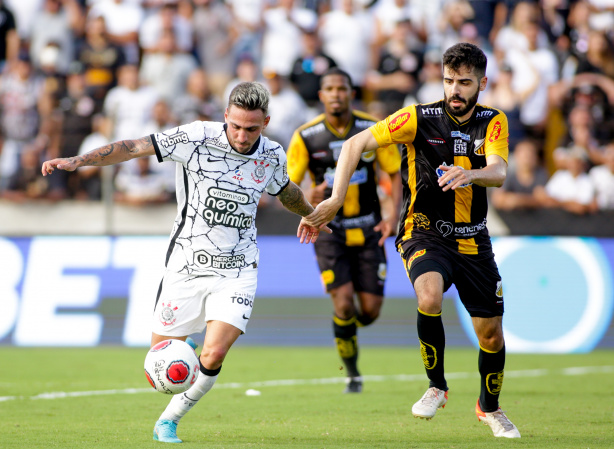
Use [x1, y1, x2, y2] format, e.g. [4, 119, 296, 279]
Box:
[418, 309, 448, 391]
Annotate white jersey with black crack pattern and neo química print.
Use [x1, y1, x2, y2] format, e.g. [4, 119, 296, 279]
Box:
[151, 121, 289, 276]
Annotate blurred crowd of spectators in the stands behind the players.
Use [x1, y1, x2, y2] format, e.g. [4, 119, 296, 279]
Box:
[0, 0, 614, 214]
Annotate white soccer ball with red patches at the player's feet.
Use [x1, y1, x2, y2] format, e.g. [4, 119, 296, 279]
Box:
[145, 340, 200, 394]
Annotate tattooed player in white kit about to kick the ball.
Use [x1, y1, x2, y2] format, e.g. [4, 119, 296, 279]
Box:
[42, 83, 330, 443]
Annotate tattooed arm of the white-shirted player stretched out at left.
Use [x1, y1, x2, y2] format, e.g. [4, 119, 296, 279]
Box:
[41, 136, 155, 176]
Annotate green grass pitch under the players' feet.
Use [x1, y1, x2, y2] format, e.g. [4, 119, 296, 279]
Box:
[0, 345, 614, 449]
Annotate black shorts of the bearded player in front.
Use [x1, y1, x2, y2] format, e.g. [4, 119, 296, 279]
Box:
[403, 240, 503, 318]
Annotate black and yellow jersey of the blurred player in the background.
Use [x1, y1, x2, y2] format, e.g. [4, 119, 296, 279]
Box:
[287, 111, 401, 228]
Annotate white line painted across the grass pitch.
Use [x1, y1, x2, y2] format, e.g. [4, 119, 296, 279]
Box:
[0, 365, 614, 402]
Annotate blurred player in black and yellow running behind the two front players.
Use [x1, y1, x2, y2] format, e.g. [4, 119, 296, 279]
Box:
[288, 68, 401, 393]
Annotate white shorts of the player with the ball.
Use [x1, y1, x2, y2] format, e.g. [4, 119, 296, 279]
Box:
[152, 269, 258, 337]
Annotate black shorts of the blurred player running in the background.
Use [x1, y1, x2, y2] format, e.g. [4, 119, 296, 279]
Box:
[314, 229, 387, 296]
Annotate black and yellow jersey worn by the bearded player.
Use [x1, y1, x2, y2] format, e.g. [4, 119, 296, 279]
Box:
[371, 100, 509, 254]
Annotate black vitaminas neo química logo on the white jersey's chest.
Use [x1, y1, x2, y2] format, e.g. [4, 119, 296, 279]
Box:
[203, 187, 254, 229]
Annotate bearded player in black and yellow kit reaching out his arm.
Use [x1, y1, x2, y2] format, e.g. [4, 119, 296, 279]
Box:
[298, 43, 520, 438]
